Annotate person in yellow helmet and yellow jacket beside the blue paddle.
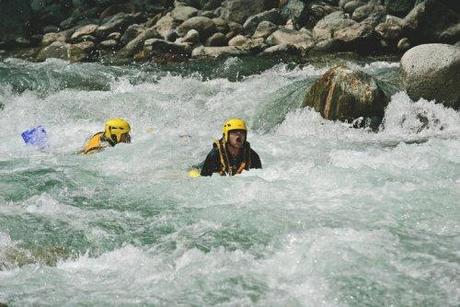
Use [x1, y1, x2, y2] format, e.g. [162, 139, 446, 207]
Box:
[81, 118, 131, 154]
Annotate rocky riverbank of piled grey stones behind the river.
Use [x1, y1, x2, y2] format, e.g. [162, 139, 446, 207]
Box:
[0, 0, 460, 63]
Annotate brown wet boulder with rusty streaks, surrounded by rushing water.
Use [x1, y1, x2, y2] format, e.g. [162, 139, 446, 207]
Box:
[303, 66, 388, 122]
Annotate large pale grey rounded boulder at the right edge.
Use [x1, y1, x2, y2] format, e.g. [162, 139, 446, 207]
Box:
[401, 44, 460, 109]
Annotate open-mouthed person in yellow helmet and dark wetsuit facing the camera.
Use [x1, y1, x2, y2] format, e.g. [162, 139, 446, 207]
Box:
[200, 118, 262, 176]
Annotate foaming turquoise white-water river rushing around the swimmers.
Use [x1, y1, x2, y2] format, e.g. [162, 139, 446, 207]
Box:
[0, 58, 460, 306]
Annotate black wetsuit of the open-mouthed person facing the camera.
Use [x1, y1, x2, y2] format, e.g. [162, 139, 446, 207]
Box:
[201, 142, 262, 176]
